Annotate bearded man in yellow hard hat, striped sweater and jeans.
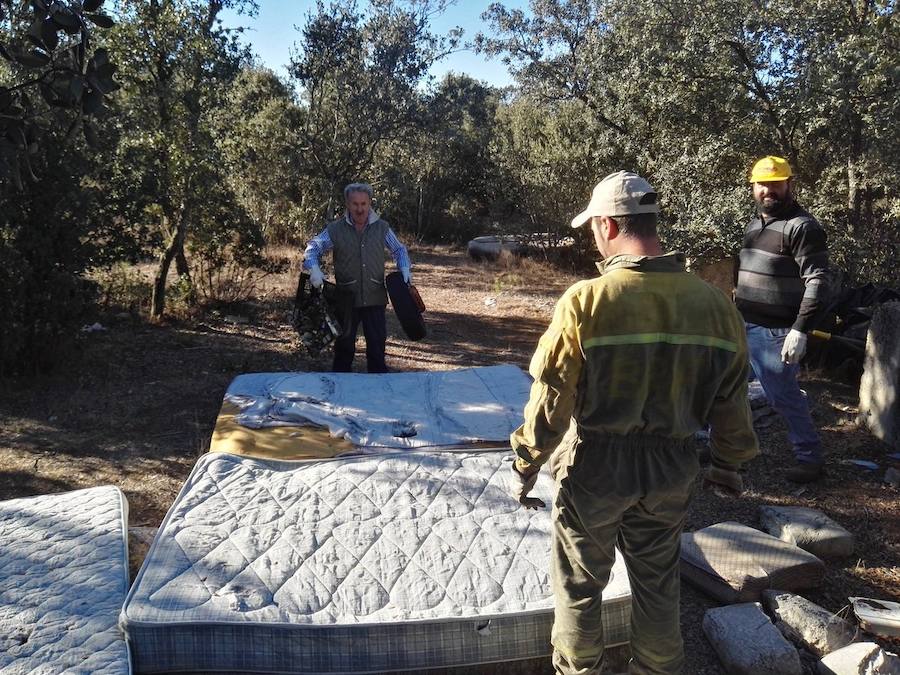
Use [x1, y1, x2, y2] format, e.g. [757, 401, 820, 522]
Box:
[735, 156, 828, 483]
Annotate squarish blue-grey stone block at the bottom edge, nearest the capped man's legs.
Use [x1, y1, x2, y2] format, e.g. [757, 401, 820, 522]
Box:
[703, 602, 803, 675]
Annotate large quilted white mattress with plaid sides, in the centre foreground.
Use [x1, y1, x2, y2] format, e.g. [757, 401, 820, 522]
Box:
[122, 451, 631, 673]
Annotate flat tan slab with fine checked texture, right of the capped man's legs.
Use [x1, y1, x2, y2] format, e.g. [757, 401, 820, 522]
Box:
[681, 522, 825, 603]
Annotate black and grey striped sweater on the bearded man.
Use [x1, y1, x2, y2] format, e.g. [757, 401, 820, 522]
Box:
[735, 203, 829, 333]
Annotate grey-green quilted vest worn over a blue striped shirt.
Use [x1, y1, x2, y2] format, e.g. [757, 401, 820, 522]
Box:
[327, 218, 390, 307]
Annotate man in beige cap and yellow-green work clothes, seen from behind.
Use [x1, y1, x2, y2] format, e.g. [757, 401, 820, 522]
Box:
[510, 171, 757, 674]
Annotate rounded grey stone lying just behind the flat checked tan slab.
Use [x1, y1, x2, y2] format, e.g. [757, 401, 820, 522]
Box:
[759, 506, 854, 558]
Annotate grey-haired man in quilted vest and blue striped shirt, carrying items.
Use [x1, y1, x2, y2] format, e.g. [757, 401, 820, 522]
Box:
[303, 183, 411, 373]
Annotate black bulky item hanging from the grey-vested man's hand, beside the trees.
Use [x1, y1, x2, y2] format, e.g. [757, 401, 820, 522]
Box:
[293, 272, 353, 356]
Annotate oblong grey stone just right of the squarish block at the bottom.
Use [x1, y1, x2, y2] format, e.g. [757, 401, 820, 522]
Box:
[763, 591, 858, 657]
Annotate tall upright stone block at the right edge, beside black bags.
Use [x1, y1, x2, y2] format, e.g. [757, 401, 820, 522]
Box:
[859, 302, 900, 448]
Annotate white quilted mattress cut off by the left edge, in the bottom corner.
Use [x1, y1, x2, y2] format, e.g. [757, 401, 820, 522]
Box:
[0, 486, 131, 675]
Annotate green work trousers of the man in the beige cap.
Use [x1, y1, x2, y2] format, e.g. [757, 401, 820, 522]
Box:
[551, 435, 700, 675]
